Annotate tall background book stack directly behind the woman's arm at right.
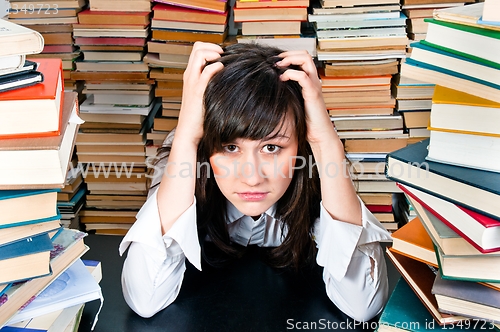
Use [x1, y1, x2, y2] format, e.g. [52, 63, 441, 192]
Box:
[308, 0, 408, 231]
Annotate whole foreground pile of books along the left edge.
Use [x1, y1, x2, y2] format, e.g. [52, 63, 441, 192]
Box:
[0, 20, 102, 330]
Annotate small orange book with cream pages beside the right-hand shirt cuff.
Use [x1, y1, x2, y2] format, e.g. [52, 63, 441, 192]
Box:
[392, 217, 438, 267]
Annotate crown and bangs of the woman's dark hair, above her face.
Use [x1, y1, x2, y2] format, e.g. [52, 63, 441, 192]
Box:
[204, 42, 304, 154]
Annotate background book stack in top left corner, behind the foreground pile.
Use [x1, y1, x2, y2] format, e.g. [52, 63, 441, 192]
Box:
[8, 0, 88, 93]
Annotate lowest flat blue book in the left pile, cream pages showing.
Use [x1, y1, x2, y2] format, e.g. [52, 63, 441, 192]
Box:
[0, 233, 53, 284]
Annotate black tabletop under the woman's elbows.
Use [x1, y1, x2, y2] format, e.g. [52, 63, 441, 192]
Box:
[79, 234, 399, 332]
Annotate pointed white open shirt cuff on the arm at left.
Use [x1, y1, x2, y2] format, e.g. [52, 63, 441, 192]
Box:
[119, 189, 201, 270]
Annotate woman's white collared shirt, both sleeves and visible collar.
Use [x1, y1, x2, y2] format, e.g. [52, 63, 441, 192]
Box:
[119, 190, 391, 321]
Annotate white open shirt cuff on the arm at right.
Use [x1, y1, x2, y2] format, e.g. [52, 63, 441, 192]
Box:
[314, 197, 391, 281]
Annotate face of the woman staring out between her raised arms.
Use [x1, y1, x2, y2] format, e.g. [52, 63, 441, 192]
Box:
[210, 116, 298, 216]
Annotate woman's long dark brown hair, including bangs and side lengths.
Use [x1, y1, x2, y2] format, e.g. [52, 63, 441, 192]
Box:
[196, 44, 320, 268]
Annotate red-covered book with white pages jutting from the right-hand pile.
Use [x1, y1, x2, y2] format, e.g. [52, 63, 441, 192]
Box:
[398, 183, 500, 253]
